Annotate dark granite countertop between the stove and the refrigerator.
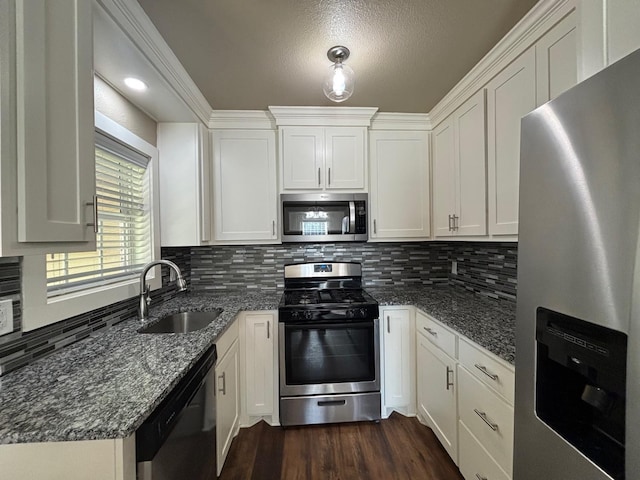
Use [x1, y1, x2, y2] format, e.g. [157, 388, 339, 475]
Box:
[366, 286, 516, 365]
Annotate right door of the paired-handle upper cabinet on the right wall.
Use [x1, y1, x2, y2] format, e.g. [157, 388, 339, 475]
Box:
[454, 89, 487, 235]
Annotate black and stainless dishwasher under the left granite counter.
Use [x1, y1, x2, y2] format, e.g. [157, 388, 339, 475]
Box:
[136, 345, 217, 480]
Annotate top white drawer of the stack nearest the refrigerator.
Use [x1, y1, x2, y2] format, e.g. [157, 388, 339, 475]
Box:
[458, 339, 515, 405]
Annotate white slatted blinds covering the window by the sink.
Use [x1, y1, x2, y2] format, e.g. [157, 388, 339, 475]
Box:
[47, 132, 152, 297]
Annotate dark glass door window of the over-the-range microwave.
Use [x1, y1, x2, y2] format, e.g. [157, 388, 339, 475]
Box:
[282, 202, 349, 235]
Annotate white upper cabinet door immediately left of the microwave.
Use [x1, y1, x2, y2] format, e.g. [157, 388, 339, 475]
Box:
[212, 130, 278, 241]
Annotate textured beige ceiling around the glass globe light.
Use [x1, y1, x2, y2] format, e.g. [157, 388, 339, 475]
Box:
[138, 0, 536, 112]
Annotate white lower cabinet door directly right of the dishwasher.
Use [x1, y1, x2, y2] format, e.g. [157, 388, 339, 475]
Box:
[216, 339, 240, 475]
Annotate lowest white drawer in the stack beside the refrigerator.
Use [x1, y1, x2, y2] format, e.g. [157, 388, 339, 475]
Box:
[458, 422, 510, 480]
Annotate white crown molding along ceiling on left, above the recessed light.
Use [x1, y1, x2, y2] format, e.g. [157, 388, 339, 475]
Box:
[95, 0, 212, 125]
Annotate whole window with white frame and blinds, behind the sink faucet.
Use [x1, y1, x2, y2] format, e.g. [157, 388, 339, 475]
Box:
[22, 112, 161, 332]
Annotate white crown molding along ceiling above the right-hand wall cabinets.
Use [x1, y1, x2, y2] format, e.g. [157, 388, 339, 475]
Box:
[429, 0, 580, 127]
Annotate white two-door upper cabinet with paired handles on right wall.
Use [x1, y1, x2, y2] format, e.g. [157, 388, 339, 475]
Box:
[433, 90, 487, 236]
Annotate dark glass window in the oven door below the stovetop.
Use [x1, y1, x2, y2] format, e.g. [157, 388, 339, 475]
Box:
[285, 321, 376, 385]
